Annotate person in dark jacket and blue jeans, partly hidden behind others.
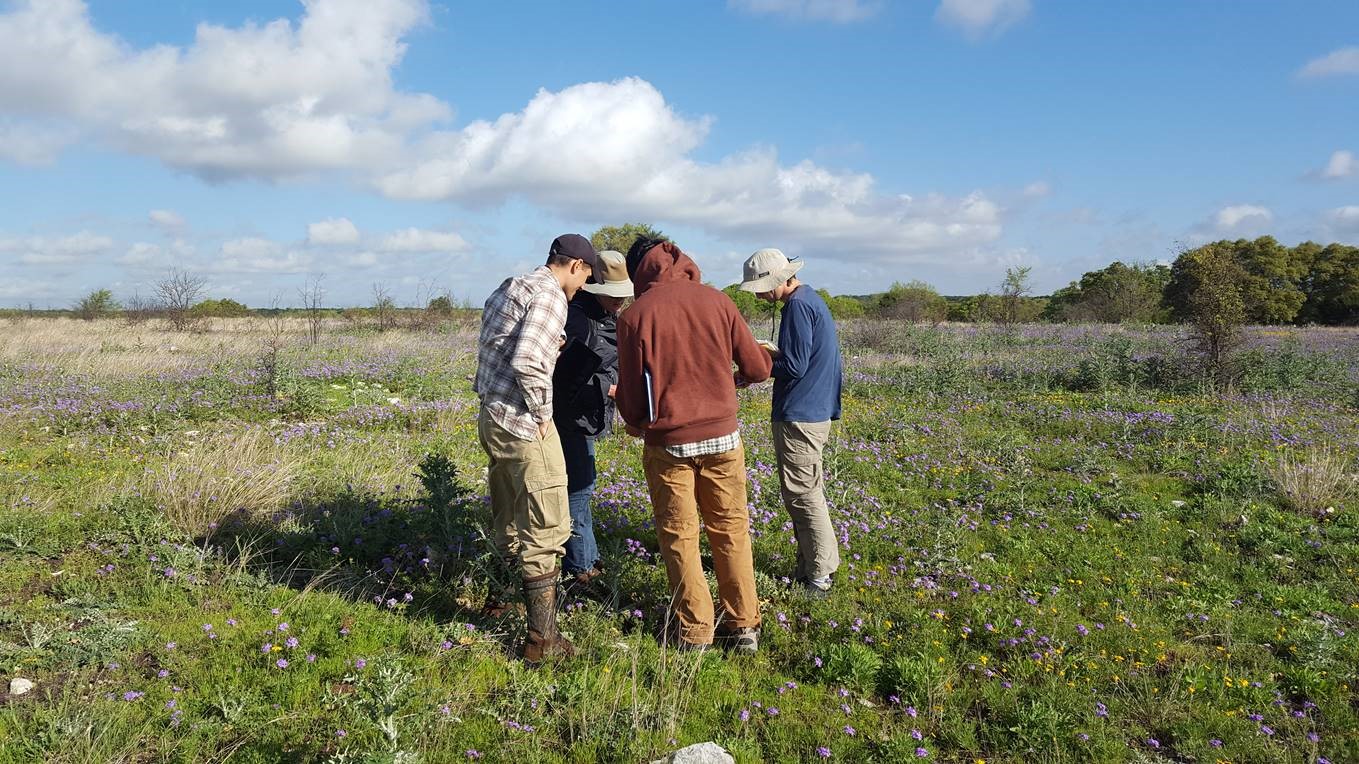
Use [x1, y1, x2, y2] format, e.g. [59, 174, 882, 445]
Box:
[553, 250, 632, 585]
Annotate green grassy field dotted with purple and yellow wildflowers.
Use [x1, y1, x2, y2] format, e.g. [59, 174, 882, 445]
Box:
[0, 319, 1359, 763]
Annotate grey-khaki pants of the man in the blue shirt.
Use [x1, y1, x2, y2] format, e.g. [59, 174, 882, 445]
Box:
[771, 421, 840, 580]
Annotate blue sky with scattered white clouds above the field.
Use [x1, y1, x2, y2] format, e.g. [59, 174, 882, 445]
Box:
[0, 0, 1359, 307]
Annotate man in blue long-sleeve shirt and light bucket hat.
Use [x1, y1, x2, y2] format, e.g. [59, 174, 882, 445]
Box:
[741, 249, 843, 598]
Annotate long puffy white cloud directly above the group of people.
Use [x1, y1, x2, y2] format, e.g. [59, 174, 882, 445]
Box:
[378, 77, 1000, 256]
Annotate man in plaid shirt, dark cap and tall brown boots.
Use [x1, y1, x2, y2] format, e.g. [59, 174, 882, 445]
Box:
[473, 234, 598, 663]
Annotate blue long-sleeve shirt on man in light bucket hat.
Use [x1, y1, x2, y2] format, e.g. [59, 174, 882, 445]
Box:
[771, 284, 843, 421]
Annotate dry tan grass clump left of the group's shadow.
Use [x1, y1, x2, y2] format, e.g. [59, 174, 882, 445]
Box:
[140, 428, 300, 537]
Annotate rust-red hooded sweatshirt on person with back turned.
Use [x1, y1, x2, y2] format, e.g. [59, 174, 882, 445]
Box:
[616, 242, 772, 446]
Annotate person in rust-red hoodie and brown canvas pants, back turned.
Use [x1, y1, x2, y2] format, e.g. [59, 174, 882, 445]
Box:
[616, 238, 772, 654]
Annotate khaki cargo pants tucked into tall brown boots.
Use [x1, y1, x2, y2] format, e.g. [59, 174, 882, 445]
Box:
[477, 409, 571, 578]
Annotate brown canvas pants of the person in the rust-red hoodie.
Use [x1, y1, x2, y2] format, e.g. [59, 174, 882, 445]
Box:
[641, 446, 760, 644]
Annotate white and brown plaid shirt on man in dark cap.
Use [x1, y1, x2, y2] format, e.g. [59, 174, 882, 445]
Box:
[473, 265, 567, 440]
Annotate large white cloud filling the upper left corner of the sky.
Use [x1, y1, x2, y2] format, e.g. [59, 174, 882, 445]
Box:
[0, 0, 450, 178]
